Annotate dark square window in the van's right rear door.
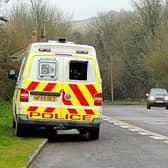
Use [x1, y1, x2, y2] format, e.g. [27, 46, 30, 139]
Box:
[69, 61, 88, 80]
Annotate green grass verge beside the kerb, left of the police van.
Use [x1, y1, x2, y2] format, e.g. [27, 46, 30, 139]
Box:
[0, 102, 42, 168]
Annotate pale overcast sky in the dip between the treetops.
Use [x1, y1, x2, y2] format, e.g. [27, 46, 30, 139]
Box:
[49, 0, 132, 20]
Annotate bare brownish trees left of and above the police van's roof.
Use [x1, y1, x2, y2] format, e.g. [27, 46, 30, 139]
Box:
[0, 0, 71, 98]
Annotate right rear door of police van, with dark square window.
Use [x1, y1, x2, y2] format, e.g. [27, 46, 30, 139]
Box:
[61, 56, 101, 122]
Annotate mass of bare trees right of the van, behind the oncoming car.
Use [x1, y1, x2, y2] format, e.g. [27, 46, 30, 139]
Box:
[73, 0, 168, 100]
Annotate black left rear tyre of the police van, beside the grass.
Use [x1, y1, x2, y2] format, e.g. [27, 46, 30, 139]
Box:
[15, 123, 28, 137]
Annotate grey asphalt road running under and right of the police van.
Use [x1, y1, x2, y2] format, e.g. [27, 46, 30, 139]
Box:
[30, 105, 168, 168]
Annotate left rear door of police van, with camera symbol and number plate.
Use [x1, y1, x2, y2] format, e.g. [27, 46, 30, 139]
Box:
[21, 56, 63, 120]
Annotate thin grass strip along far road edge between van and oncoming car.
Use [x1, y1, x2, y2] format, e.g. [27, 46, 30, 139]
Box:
[104, 100, 146, 105]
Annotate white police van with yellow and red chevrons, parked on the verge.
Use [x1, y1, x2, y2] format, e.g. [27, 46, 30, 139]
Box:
[9, 39, 103, 139]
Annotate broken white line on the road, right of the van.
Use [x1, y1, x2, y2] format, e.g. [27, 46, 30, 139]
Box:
[103, 116, 168, 144]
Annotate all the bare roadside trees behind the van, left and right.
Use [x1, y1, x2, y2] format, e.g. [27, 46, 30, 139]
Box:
[0, 0, 168, 100]
